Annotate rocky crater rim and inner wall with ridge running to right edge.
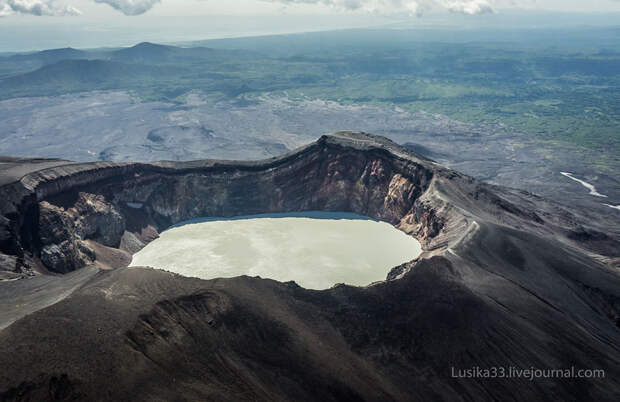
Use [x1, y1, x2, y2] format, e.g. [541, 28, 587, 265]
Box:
[0, 132, 619, 280]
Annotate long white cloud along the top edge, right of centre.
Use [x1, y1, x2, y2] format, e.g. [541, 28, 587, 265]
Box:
[263, 0, 494, 15]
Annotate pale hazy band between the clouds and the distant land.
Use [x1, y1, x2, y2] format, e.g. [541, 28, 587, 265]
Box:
[0, 10, 620, 53]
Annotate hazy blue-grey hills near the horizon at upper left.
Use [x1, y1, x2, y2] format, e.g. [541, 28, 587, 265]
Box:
[0, 42, 263, 99]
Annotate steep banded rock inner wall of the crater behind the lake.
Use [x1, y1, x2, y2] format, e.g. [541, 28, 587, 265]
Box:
[10, 140, 443, 272]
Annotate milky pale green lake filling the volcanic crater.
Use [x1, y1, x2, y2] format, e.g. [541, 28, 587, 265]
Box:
[131, 212, 421, 289]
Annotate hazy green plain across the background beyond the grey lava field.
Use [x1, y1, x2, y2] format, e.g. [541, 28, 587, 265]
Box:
[0, 29, 620, 149]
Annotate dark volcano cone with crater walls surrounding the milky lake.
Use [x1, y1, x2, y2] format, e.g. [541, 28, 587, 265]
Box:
[0, 132, 620, 401]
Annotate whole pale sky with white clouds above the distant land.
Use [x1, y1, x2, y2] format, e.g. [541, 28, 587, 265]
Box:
[0, 0, 620, 53]
